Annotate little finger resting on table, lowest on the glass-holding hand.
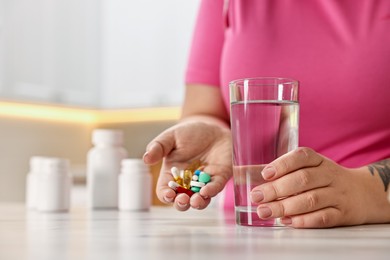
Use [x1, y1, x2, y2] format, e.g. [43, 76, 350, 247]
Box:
[281, 207, 343, 228]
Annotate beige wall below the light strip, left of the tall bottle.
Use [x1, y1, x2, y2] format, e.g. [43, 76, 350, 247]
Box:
[0, 117, 91, 201]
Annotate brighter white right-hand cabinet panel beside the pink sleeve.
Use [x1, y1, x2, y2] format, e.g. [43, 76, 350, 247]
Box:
[100, 0, 199, 108]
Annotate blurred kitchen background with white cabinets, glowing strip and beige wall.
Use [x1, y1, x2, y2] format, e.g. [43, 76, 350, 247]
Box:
[0, 0, 199, 201]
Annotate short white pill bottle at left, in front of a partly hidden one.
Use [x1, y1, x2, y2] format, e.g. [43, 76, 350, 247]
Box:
[37, 157, 72, 212]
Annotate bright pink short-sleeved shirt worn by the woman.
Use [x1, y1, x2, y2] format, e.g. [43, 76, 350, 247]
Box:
[186, 0, 390, 208]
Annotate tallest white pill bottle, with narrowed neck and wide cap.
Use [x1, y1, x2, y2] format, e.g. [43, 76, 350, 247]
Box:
[87, 129, 127, 209]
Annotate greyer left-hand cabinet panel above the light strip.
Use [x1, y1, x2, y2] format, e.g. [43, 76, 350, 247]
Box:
[0, 0, 100, 106]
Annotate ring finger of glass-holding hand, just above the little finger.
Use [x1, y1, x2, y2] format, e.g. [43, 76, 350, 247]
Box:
[257, 188, 334, 219]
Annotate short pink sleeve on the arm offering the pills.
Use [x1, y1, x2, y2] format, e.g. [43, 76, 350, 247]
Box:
[185, 0, 224, 86]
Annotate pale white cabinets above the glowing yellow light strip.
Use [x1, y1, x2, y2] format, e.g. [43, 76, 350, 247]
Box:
[0, 0, 199, 108]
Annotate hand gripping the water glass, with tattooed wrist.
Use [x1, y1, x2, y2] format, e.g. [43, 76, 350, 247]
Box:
[251, 148, 390, 228]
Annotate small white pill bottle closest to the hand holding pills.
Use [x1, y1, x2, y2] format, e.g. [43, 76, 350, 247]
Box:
[119, 158, 152, 211]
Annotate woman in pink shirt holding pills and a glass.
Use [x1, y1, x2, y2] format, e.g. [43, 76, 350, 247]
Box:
[144, 0, 390, 228]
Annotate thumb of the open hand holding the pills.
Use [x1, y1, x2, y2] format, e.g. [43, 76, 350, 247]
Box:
[143, 131, 175, 164]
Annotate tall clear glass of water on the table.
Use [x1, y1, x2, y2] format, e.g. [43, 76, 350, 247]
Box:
[229, 77, 299, 226]
